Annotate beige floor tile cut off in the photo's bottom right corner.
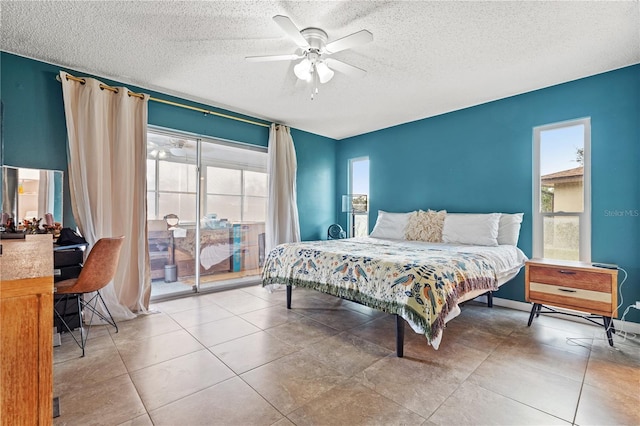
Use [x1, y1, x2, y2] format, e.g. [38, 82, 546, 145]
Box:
[575, 384, 640, 426]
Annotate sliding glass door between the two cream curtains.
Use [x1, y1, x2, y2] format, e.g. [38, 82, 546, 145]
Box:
[147, 129, 267, 298]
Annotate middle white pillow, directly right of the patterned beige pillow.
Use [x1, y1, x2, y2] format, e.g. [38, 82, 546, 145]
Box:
[442, 213, 500, 246]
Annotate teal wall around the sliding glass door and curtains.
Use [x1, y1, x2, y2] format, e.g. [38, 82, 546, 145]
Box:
[0, 52, 337, 239]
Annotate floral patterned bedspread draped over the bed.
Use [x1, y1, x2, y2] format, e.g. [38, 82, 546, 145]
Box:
[262, 238, 498, 348]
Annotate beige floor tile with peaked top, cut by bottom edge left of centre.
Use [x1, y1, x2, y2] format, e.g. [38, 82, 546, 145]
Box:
[151, 377, 283, 426]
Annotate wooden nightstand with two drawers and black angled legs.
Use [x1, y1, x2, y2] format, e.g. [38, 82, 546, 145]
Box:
[525, 259, 618, 346]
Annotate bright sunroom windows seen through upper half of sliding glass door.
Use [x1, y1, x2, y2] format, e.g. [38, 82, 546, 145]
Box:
[147, 131, 268, 223]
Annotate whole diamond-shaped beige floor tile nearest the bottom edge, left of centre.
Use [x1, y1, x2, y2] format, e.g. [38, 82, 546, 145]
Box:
[240, 353, 345, 414]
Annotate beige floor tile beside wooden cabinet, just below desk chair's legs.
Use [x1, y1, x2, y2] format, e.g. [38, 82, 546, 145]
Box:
[53, 336, 127, 396]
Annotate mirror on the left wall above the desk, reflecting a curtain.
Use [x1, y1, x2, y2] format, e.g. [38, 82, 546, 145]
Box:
[0, 166, 63, 223]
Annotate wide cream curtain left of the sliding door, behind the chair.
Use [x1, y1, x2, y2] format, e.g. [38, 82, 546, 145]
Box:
[60, 71, 151, 320]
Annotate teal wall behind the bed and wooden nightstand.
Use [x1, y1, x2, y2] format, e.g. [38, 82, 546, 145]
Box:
[336, 65, 640, 322]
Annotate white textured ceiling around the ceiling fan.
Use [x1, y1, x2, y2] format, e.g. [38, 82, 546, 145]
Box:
[0, 0, 640, 139]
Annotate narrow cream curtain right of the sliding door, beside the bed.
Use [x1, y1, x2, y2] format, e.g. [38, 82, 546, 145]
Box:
[265, 124, 300, 253]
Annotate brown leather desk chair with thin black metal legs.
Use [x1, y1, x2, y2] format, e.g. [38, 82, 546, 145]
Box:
[53, 237, 124, 356]
